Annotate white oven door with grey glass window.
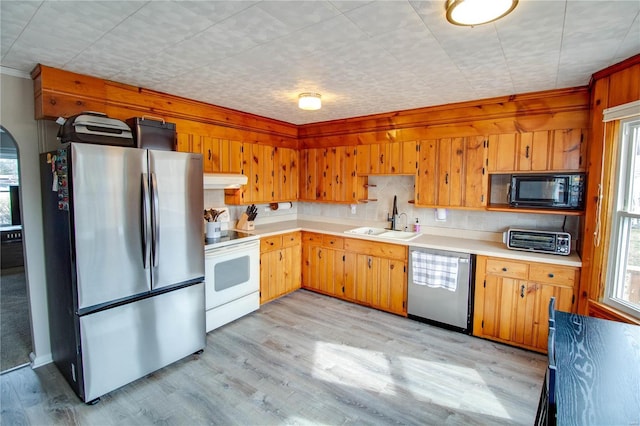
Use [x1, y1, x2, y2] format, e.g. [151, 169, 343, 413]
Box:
[204, 240, 260, 310]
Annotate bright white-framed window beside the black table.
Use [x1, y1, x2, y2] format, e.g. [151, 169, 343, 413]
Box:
[605, 116, 640, 317]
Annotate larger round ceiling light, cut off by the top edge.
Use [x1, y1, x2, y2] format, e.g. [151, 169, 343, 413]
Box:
[446, 0, 518, 26]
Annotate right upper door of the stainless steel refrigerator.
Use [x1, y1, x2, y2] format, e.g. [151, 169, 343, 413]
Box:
[149, 150, 204, 289]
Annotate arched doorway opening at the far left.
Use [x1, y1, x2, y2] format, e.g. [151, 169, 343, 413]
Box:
[0, 125, 33, 372]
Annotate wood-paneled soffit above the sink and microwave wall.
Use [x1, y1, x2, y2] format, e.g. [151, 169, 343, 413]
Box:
[298, 87, 589, 148]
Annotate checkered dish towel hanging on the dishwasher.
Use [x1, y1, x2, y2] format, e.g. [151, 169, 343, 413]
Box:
[411, 251, 458, 291]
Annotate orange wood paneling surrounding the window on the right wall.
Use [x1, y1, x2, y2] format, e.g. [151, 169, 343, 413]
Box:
[578, 55, 640, 321]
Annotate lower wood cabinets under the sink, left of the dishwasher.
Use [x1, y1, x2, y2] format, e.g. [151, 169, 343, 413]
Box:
[302, 232, 407, 316]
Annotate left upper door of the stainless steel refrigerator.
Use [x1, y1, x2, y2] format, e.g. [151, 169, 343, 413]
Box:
[69, 143, 151, 310]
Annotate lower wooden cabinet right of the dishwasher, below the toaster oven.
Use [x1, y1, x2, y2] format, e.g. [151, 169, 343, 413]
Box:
[473, 256, 580, 352]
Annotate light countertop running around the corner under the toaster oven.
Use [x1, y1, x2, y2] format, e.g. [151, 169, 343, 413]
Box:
[239, 220, 582, 267]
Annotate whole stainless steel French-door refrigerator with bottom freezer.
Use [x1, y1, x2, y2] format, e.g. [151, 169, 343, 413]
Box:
[41, 143, 206, 402]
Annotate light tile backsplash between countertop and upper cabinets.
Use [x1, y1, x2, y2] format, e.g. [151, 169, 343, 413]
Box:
[204, 176, 580, 239]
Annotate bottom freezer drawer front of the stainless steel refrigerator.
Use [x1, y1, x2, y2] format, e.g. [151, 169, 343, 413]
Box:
[80, 283, 206, 402]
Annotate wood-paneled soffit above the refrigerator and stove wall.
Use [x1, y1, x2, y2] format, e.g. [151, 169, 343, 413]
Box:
[31, 65, 298, 149]
